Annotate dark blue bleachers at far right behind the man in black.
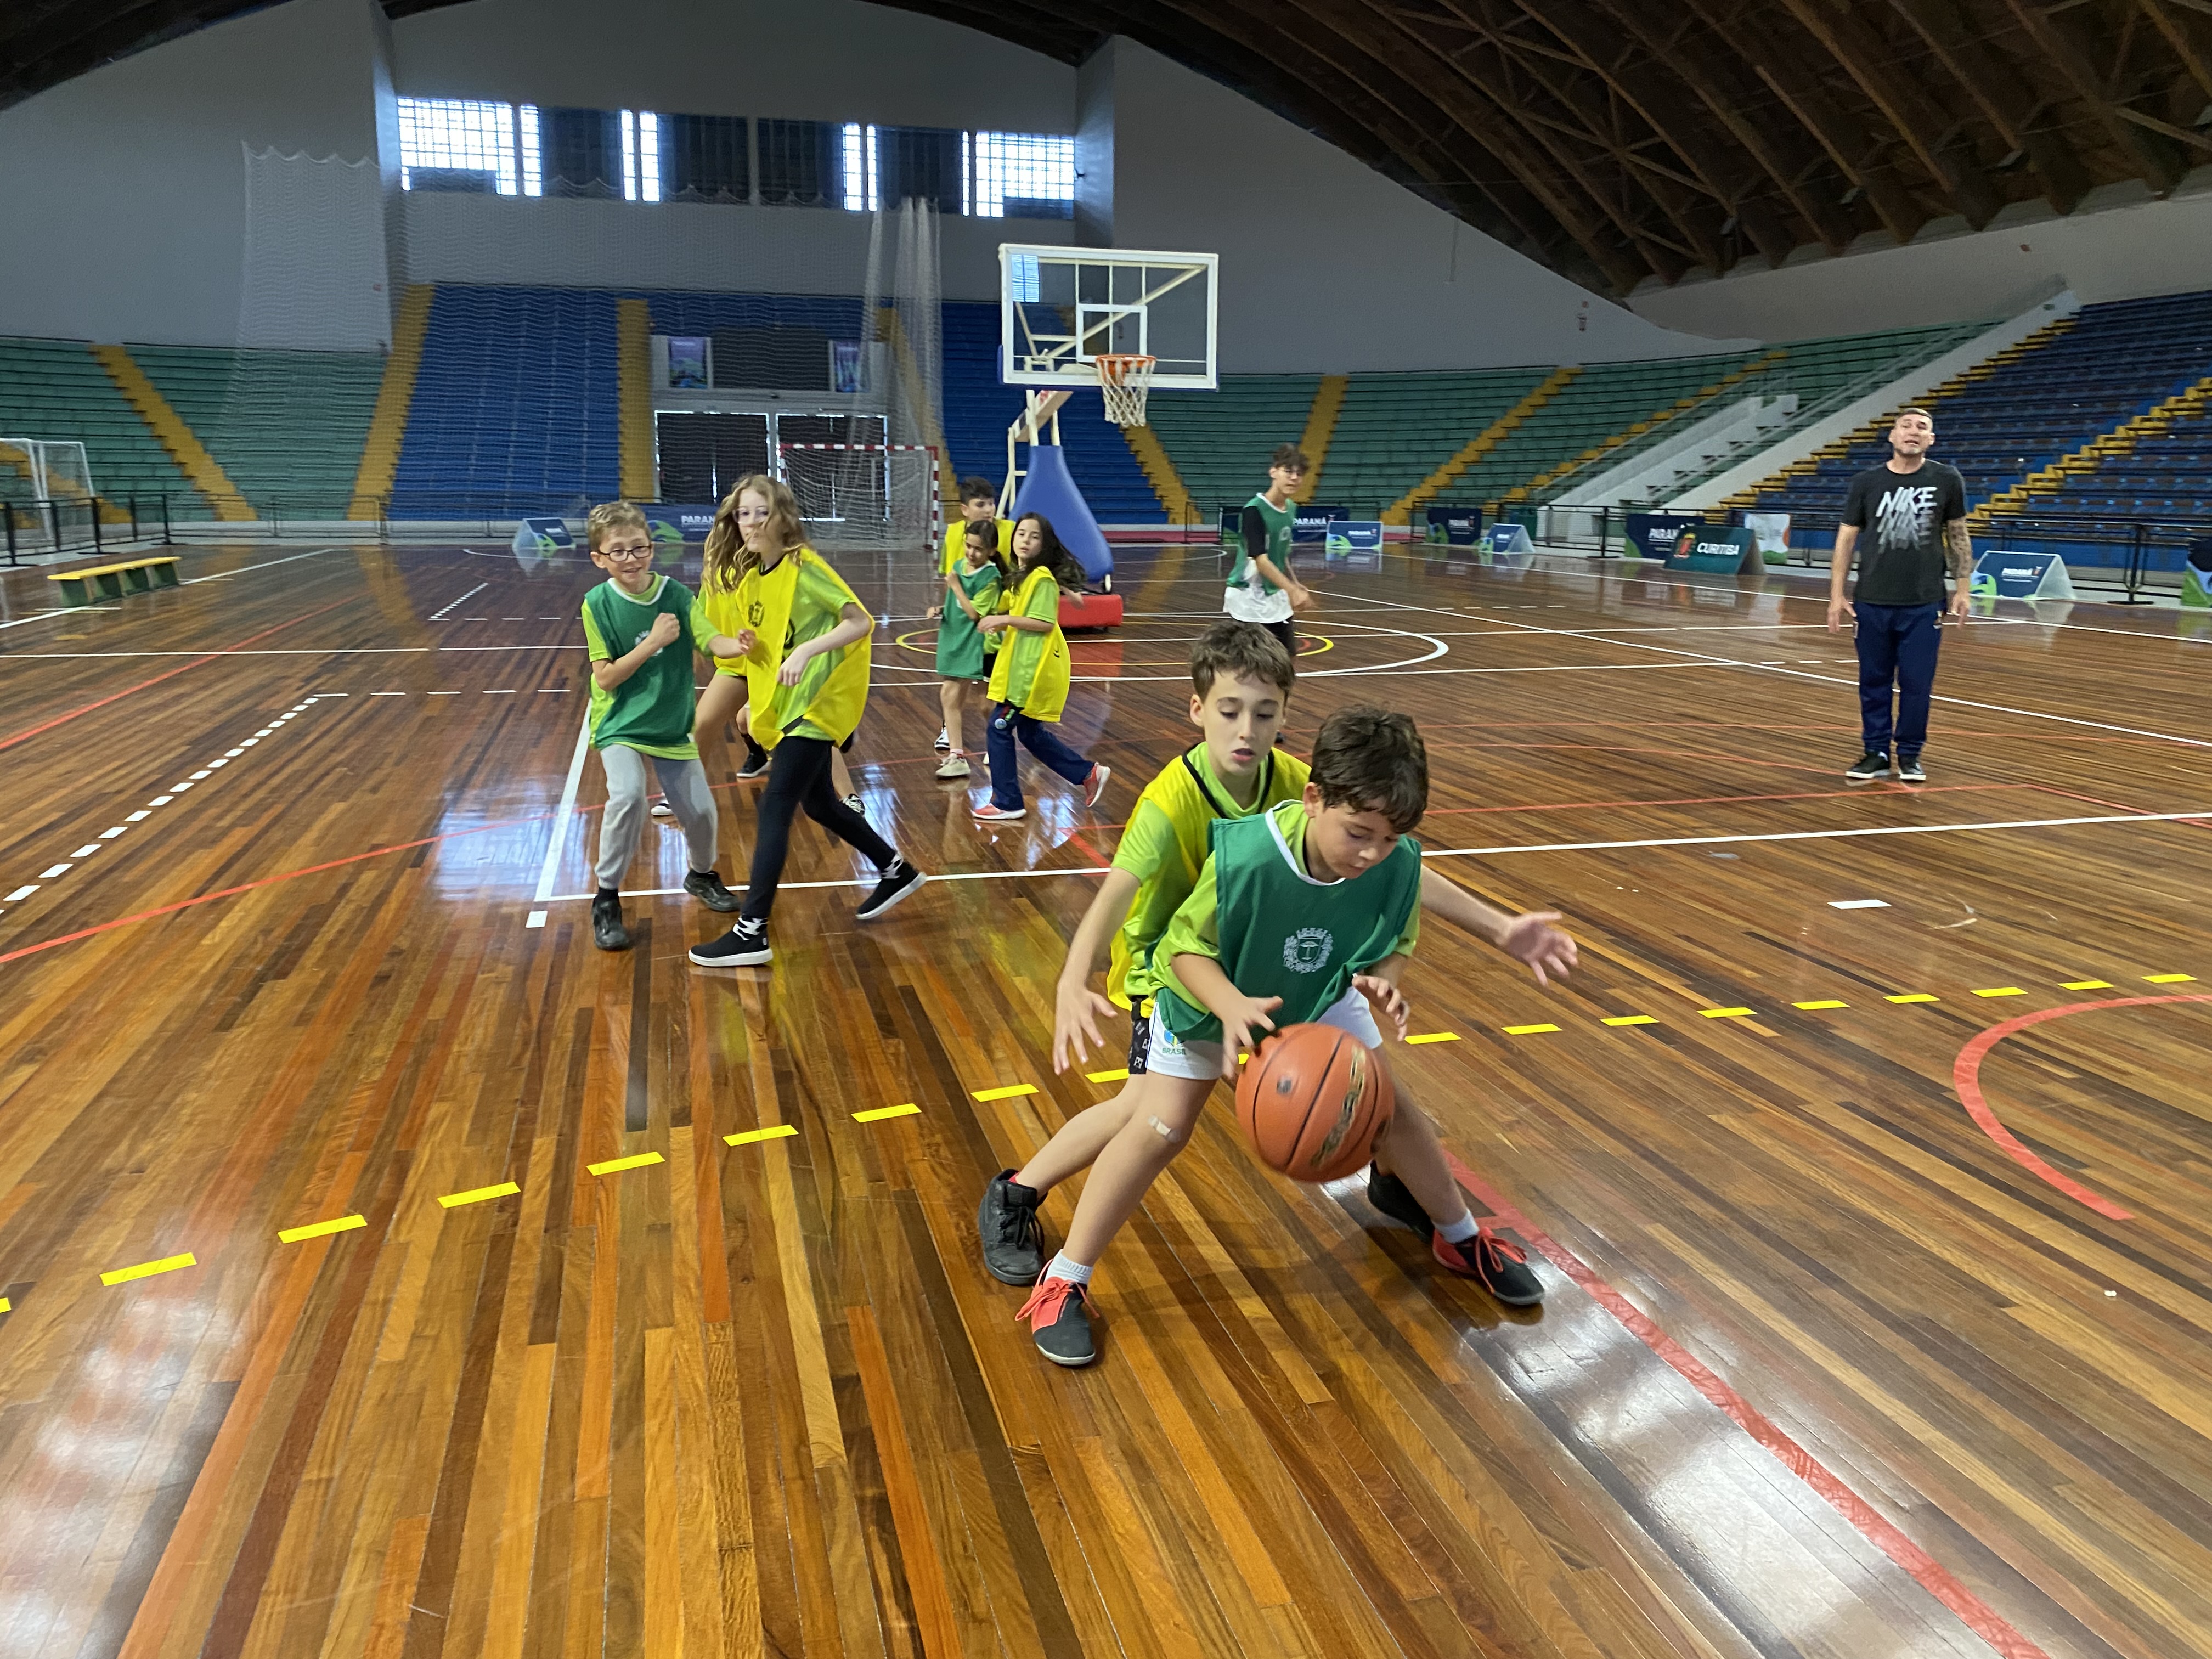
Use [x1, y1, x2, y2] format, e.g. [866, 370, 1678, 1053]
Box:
[1730, 292, 2212, 522]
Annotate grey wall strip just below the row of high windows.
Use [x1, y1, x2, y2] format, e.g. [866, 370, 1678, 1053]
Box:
[400, 190, 1073, 298]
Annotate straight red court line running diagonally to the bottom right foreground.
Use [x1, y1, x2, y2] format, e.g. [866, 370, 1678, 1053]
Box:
[1444, 1159, 2052, 1659]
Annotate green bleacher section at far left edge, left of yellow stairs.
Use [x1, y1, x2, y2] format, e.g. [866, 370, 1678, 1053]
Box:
[0, 338, 208, 517]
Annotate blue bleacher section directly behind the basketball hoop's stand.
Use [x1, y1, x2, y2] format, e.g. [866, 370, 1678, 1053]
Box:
[945, 301, 1166, 524]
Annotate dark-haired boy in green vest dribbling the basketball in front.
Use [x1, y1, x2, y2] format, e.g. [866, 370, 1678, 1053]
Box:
[995, 708, 1573, 1365]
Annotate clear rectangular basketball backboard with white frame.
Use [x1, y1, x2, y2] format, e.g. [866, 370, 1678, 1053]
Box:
[997, 241, 1219, 392]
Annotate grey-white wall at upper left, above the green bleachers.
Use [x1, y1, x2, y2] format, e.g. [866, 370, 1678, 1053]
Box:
[0, 0, 390, 347]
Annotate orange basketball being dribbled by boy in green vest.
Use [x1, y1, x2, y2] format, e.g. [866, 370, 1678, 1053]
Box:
[1237, 1026, 1396, 1181]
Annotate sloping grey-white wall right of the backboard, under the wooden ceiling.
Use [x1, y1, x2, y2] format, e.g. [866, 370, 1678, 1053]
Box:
[1102, 38, 1730, 374]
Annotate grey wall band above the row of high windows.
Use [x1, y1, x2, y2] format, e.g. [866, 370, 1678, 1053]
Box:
[392, 0, 1075, 133]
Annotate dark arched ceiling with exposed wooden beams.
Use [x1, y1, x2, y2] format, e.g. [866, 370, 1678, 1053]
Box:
[0, 0, 2212, 294]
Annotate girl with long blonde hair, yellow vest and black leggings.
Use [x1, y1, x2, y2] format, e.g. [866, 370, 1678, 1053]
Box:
[690, 473, 927, 967]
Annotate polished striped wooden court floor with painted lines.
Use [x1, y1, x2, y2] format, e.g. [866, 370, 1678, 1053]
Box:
[0, 544, 2212, 1659]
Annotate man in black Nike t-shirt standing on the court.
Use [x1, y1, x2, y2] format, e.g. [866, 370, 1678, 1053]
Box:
[1827, 409, 1973, 783]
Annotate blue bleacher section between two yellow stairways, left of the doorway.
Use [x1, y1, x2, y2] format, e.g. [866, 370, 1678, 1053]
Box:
[390, 285, 622, 517]
